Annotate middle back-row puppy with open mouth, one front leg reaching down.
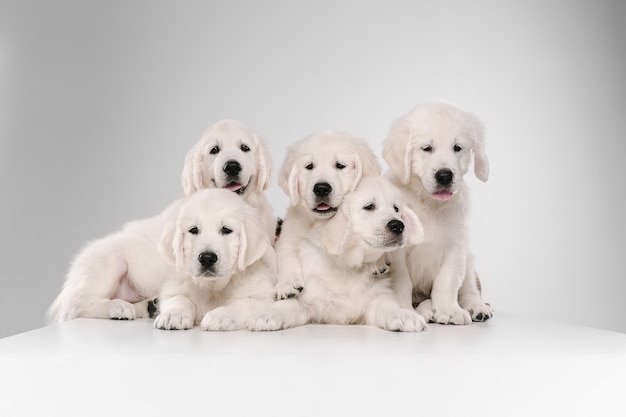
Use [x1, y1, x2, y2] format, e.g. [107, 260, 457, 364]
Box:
[276, 131, 380, 299]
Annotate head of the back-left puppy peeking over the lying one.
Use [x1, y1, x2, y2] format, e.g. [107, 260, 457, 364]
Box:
[181, 120, 272, 196]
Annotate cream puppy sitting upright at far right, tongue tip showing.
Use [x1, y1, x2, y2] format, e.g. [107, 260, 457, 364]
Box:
[383, 101, 493, 324]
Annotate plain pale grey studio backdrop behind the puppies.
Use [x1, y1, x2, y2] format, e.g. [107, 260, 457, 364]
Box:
[0, 0, 626, 337]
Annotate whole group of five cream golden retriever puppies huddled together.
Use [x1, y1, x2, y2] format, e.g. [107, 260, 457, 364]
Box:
[47, 101, 493, 332]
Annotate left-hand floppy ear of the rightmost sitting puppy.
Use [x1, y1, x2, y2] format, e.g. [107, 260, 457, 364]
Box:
[383, 119, 413, 184]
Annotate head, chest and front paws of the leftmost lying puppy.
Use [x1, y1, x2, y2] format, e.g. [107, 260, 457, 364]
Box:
[154, 190, 283, 330]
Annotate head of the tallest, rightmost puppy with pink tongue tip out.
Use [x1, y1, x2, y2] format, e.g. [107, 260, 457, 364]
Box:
[383, 101, 489, 201]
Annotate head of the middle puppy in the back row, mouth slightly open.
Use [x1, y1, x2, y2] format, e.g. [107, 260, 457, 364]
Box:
[278, 131, 380, 218]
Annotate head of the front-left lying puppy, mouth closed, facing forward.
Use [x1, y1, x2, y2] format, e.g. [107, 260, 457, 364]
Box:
[161, 189, 271, 283]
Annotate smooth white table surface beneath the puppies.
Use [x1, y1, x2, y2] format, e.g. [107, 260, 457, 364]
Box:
[0, 314, 626, 417]
